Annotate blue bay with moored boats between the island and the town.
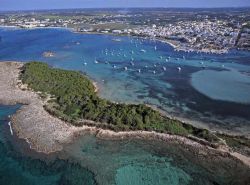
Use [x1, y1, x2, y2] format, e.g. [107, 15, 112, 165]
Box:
[0, 28, 250, 135]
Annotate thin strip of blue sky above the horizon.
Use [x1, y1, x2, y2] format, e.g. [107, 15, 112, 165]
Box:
[0, 0, 250, 11]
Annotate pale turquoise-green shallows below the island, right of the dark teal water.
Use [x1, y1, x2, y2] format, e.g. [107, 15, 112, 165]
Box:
[62, 134, 250, 185]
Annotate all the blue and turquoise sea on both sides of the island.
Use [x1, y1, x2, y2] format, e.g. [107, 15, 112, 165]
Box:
[0, 28, 250, 185]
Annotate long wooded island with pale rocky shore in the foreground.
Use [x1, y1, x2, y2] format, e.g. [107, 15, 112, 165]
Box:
[0, 62, 250, 166]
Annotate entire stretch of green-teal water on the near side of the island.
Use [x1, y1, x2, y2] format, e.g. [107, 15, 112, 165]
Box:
[0, 105, 250, 185]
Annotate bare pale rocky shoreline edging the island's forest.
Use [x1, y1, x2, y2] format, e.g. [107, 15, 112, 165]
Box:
[0, 62, 250, 167]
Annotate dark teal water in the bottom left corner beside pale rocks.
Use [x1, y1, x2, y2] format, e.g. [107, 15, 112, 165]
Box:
[0, 105, 95, 185]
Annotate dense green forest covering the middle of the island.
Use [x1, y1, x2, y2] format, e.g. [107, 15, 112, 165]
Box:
[20, 62, 223, 141]
